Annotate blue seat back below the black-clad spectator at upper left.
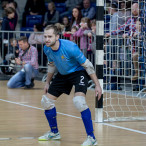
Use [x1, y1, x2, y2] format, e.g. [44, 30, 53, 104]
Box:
[26, 15, 43, 27]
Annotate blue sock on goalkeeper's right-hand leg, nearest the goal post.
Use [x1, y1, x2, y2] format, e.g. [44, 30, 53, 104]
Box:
[81, 108, 95, 139]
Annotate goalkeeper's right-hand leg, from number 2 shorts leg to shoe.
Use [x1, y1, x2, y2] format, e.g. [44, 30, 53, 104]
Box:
[72, 71, 97, 145]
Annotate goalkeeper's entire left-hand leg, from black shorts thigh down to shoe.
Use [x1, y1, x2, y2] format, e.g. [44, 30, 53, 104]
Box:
[38, 74, 66, 140]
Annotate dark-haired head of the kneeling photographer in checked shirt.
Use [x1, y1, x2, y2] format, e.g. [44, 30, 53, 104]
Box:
[18, 36, 29, 50]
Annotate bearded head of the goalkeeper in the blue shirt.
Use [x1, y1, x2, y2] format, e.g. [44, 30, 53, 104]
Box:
[44, 25, 59, 47]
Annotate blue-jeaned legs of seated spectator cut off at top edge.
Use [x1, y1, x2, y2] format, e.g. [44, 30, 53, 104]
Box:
[60, 0, 82, 20]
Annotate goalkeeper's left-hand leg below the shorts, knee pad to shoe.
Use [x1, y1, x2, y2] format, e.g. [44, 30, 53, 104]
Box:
[38, 93, 61, 141]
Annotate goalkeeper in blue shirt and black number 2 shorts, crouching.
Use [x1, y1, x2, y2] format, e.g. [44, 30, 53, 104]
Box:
[38, 25, 102, 146]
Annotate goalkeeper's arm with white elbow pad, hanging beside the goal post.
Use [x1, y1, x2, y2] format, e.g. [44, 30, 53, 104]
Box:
[81, 59, 102, 100]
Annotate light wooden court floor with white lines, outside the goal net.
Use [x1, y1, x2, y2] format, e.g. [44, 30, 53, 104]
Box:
[0, 81, 146, 146]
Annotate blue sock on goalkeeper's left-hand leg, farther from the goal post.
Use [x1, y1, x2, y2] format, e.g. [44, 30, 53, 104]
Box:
[45, 107, 58, 133]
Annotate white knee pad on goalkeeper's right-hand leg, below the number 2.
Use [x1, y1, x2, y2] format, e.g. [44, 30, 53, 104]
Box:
[73, 96, 88, 112]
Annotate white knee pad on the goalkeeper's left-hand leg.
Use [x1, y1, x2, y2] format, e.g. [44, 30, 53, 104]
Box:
[41, 95, 55, 110]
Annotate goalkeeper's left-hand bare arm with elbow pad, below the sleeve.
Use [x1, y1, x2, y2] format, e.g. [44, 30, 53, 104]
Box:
[44, 62, 56, 93]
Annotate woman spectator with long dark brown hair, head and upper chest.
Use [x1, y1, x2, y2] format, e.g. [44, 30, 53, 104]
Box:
[71, 7, 82, 28]
